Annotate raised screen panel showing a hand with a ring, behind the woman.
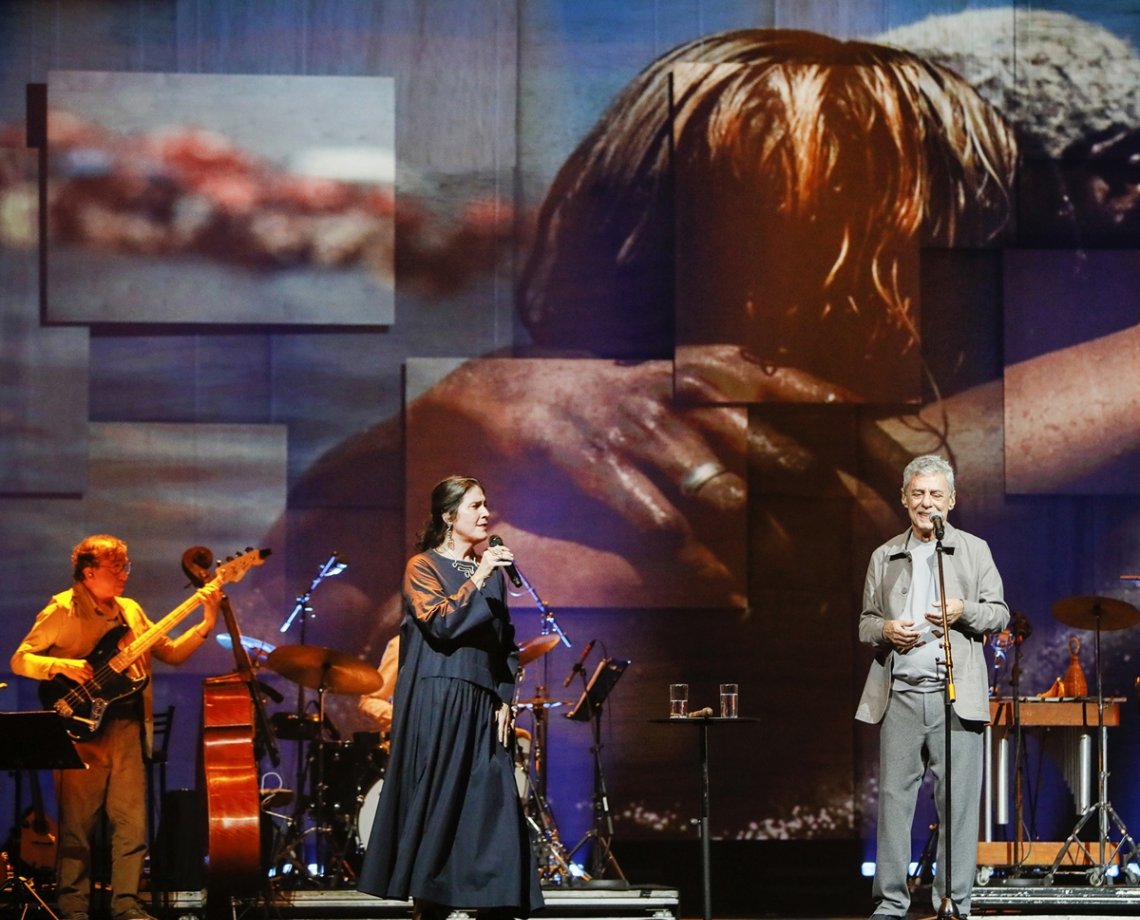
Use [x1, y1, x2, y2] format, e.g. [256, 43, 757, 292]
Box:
[406, 359, 747, 608]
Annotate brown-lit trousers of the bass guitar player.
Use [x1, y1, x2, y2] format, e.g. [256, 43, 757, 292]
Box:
[56, 719, 147, 918]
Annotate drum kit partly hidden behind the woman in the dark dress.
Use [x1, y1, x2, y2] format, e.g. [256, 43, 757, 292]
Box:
[242, 634, 569, 888]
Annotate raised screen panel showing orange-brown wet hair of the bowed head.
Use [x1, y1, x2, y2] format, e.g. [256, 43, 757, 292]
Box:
[665, 64, 921, 404]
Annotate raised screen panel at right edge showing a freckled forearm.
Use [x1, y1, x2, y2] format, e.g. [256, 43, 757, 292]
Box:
[1004, 250, 1140, 495]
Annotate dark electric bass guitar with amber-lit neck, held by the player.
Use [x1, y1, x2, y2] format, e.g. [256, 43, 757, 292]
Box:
[39, 549, 270, 741]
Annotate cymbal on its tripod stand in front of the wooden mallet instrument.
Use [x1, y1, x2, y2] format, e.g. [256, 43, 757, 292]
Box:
[1047, 595, 1140, 887]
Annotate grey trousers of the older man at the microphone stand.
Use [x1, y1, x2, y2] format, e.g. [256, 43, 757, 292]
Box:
[871, 691, 984, 917]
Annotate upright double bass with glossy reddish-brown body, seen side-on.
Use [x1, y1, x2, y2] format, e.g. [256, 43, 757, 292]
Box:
[182, 546, 279, 920]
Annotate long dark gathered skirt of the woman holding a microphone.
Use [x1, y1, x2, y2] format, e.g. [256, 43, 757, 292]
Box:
[357, 677, 543, 917]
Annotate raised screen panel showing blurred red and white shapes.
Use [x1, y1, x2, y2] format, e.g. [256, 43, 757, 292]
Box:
[47, 72, 396, 326]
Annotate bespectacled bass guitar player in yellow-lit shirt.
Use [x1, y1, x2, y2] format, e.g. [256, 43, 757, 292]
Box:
[11, 534, 229, 920]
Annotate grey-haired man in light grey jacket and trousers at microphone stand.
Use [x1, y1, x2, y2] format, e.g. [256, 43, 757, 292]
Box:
[855, 455, 1009, 920]
